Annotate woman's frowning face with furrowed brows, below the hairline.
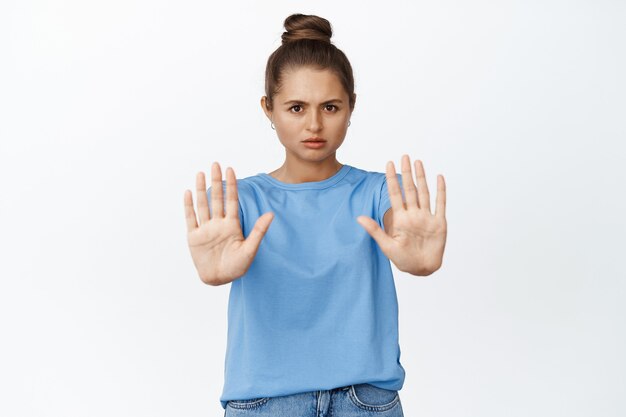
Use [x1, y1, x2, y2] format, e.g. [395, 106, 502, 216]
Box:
[261, 67, 356, 161]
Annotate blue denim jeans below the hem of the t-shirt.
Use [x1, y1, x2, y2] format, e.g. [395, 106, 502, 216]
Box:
[224, 384, 404, 417]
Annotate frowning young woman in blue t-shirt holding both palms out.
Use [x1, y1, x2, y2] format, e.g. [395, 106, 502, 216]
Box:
[184, 14, 447, 417]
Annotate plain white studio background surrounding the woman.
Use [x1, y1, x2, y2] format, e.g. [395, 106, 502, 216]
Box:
[0, 0, 626, 417]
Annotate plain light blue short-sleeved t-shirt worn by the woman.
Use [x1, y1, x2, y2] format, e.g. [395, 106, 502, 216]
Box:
[207, 164, 405, 409]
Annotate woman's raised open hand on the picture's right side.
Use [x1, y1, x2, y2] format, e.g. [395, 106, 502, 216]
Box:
[357, 154, 447, 276]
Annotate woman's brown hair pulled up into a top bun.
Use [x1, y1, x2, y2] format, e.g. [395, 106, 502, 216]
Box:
[265, 14, 354, 110]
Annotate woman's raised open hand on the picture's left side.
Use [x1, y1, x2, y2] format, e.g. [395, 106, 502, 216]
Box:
[184, 162, 274, 285]
